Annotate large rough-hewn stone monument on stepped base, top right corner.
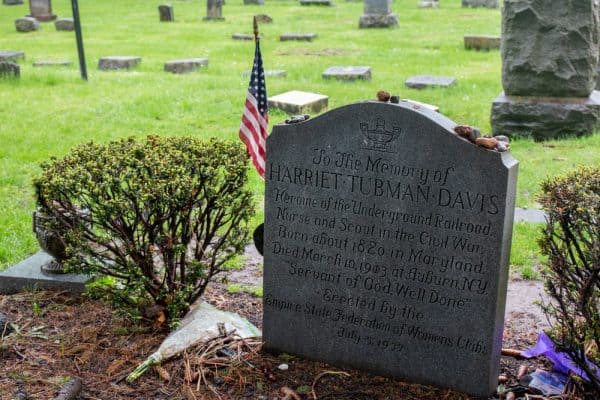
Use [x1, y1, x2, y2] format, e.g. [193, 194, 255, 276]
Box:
[491, 0, 600, 140]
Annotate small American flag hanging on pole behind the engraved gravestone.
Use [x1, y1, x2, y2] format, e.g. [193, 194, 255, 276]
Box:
[240, 27, 269, 178]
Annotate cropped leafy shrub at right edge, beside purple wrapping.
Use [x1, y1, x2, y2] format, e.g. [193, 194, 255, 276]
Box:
[539, 166, 600, 398]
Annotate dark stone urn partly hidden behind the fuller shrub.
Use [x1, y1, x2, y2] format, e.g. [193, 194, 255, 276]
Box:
[33, 207, 89, 274]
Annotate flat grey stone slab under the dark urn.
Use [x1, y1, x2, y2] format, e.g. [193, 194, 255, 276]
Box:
[0, 251, 92, 294]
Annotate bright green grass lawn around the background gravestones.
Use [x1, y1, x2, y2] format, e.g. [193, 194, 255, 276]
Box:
[0, 0, 600, 270]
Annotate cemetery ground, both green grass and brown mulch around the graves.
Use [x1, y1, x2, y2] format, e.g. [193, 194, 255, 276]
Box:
[0, 0, 600, 399]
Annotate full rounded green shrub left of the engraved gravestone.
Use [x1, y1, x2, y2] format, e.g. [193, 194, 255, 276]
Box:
[34, 136, 254, 322]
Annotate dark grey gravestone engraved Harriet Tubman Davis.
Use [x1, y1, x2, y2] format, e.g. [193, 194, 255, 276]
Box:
[263, 102, 517, 396]
